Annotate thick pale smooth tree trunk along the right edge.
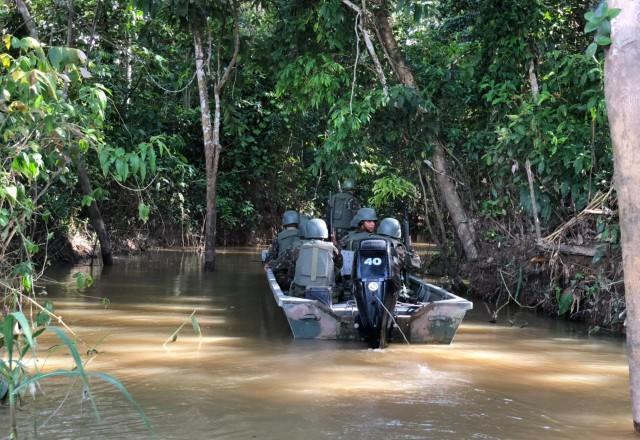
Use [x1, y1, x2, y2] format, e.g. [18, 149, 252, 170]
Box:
[604, 0, 640, 432]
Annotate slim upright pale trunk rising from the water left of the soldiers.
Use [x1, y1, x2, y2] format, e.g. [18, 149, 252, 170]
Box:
[192, 25, 220, 271]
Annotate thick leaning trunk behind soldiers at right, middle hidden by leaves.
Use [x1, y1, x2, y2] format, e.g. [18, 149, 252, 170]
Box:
[374, 0, 478, 260]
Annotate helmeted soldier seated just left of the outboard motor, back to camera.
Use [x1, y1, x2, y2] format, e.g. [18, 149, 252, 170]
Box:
[289, 218, 342, 296]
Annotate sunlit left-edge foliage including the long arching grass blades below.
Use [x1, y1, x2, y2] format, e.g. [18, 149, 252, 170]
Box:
[0, 36, 151, 436]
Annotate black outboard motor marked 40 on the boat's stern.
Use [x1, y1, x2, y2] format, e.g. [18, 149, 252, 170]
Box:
[353, 238, 398, 348]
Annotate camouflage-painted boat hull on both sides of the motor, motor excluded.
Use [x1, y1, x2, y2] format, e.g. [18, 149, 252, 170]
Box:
[266, 269, 473, 344]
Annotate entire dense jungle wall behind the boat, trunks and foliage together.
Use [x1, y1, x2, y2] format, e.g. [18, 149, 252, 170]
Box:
[0, 0, 624, 326]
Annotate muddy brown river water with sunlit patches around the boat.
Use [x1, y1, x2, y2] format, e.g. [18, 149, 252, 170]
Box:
[0, 249, 633, 440]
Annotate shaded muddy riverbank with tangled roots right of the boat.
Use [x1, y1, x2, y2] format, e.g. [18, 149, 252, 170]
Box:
[424, 239, 626, 334]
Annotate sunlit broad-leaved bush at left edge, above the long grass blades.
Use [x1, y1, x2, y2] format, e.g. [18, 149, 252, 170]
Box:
[0, 36, 106, 288]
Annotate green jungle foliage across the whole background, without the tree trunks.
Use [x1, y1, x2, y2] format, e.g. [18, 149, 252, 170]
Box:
[0, 0, 619, 312]
